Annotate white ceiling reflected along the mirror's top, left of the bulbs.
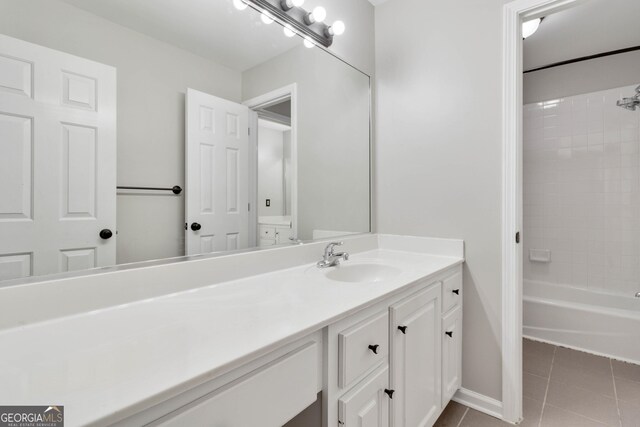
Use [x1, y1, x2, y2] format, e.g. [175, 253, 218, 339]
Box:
[62, 0, 301, 71]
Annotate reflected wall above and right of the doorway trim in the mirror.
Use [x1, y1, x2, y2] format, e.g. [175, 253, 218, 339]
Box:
[242, 46, 370, 240]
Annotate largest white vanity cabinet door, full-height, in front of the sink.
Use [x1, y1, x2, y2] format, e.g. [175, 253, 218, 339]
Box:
[390, 283, 442, 427]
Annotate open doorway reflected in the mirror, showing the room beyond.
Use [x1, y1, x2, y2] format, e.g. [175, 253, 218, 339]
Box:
[257, 99, 294, 247]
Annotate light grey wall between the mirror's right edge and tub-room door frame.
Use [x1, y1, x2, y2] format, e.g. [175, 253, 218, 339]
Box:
[375, 0, 505, 400]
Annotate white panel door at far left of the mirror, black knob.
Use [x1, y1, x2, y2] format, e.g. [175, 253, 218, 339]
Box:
[0, 35, 116, 280]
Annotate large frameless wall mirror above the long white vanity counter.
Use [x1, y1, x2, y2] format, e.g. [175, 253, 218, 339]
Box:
[0, 0, 370, 286]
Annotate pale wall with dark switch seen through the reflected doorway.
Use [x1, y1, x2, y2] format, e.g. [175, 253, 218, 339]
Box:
[258, 126, 284, 216]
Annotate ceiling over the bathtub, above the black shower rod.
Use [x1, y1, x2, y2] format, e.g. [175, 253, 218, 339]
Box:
[524, 0, 640, 70]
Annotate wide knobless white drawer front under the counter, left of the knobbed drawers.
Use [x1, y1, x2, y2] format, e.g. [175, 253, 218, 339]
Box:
[152, 342, 319, 427]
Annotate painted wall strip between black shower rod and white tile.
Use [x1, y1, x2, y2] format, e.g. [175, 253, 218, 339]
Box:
[523, 49, 640, 104]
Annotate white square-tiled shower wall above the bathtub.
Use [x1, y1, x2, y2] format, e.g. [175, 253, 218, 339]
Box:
[523, 82, 640, 295]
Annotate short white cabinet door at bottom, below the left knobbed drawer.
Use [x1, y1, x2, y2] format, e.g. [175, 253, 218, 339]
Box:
[338, 365, 394, 427]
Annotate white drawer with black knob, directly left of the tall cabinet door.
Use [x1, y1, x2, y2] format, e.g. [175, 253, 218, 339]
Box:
[338, 311, 389, 388]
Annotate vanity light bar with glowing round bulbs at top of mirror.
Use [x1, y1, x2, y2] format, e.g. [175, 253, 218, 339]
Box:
[239, 0, 345, 48]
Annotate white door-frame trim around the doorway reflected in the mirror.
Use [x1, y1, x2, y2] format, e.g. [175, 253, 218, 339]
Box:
[243, 83, 298, 239]
